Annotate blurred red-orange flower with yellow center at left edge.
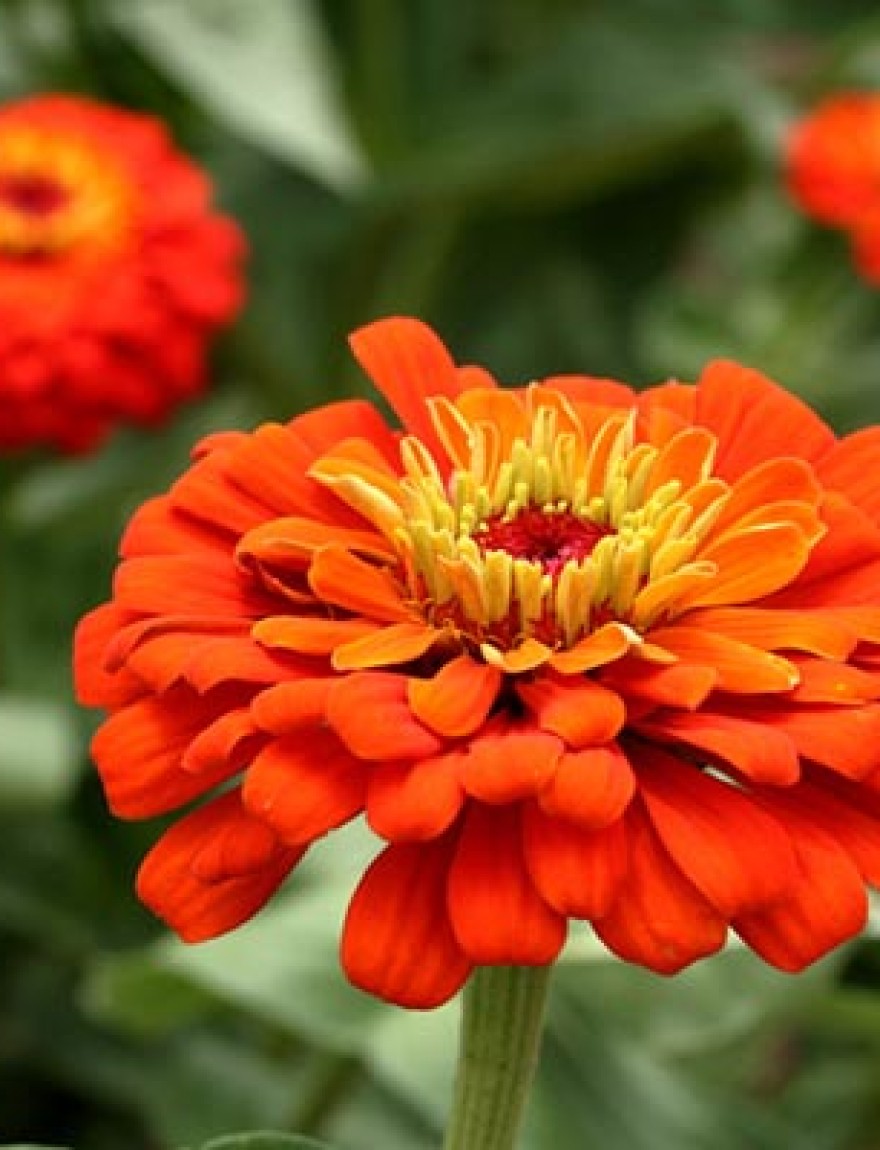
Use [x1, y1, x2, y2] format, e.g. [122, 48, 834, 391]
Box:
[0, 95, 244, 451]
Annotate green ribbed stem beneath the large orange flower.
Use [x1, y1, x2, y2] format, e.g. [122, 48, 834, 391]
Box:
[443, 966, 551, 1150]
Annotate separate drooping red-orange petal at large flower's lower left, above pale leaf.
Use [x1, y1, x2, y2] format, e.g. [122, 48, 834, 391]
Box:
[137, 791, 304, 942]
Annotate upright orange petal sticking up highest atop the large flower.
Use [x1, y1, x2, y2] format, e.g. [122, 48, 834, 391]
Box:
[349, 316, 462, 458]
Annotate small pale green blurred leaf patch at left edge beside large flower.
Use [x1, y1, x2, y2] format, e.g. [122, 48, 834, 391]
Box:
[0, 695, 78, 811]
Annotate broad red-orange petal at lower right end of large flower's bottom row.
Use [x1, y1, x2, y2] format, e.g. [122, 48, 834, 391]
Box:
[734, 810, 867, 972]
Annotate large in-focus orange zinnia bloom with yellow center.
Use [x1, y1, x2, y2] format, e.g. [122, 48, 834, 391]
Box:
[76, 319, 880, 1007]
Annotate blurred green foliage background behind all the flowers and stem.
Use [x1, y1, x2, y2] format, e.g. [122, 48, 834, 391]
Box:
[0, 0, 880, 1150]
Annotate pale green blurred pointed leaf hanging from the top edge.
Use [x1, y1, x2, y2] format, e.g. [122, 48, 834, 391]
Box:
[109, 0, 365, 190]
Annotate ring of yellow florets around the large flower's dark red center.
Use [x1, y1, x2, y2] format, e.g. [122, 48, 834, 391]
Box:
[393, 389, 728, 647]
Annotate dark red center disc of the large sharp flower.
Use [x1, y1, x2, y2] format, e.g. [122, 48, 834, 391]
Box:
[474, 507, 611, 577]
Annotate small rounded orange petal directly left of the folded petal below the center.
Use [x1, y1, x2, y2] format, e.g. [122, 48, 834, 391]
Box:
[327, 670, 443, 760]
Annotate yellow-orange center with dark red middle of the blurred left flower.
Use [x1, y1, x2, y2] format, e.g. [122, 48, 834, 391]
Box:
[0, 127, 133, 260]
